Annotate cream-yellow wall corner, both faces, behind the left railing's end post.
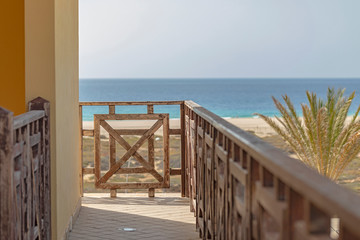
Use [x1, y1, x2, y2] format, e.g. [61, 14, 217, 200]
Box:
[25, 0, 81, 239]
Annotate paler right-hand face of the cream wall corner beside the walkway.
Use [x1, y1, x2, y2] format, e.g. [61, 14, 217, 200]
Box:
[55, 0, 81, 239]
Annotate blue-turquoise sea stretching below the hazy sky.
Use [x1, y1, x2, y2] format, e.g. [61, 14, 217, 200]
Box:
[79, 78, 360, 121]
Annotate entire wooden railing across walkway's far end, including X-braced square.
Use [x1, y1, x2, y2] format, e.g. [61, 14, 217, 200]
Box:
[79, 101, 186, 197]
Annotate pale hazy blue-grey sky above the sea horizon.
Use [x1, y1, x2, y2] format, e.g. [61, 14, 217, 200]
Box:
[80, 0, 360, 78]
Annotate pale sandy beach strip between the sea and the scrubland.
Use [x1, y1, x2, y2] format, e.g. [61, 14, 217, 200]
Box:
[83, 118, 275, 136]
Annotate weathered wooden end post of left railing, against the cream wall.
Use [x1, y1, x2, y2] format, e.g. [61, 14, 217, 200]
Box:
[29, 97, 51, 239]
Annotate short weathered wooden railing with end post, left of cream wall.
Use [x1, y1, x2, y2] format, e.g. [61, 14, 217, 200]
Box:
[0, 98, 51, 240]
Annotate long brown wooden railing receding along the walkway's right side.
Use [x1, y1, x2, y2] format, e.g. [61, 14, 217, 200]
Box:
[185, 101, 360, 240]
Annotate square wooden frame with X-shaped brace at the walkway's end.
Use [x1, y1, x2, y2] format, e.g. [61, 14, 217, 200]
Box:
[94, 114, 170, 190]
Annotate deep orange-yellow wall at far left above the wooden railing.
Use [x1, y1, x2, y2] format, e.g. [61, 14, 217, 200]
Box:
[0, 0, 25, 115]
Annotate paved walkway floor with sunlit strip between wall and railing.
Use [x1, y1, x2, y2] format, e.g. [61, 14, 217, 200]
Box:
[69, 193, 199, 240]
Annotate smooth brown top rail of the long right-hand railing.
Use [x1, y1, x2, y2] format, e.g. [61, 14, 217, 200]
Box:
[185, 101, 360, 234]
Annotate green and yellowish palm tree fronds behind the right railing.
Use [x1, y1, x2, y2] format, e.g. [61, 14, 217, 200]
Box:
[255, 88, 360, 180]
